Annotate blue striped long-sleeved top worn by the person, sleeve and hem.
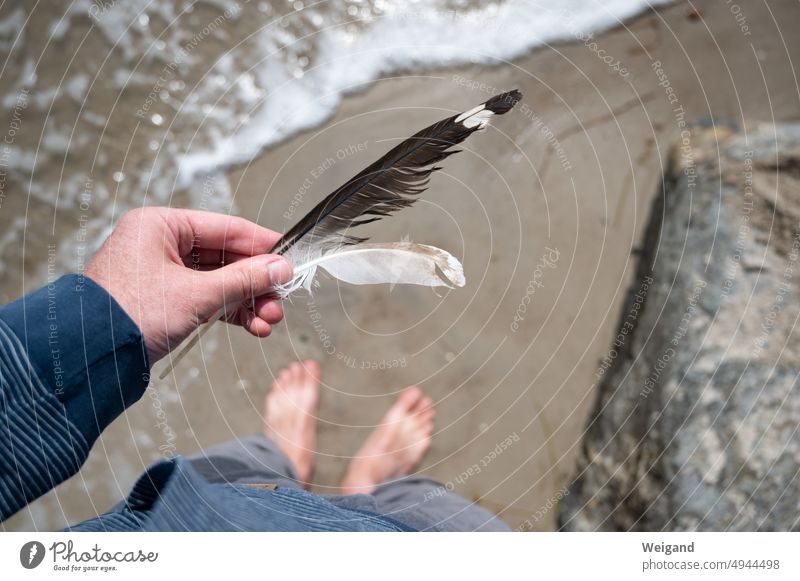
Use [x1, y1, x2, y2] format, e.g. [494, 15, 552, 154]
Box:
[0, 275, 409, 531]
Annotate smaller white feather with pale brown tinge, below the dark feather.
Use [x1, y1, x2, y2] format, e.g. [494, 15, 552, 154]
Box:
[275, 242, 465, 298]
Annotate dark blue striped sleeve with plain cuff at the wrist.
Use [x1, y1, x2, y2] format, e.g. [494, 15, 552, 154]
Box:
[0, 275, 150, 522]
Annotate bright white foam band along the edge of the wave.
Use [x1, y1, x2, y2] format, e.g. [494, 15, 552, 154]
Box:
[173, 0, 667, 187]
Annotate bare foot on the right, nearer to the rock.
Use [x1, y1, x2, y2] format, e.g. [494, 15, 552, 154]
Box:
[342, 386, 435, 494]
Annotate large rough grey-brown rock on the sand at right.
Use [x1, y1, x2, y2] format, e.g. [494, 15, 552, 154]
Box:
[559, 124, 800, 531]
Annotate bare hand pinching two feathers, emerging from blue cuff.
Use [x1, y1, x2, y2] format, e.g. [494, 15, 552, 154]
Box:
[84, 208, 292, 365]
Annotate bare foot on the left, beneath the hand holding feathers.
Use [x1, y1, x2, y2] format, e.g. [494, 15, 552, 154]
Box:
[264, 359, 320, 488]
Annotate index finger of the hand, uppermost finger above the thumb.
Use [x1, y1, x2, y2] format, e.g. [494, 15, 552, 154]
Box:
[173, 209, 281, 256]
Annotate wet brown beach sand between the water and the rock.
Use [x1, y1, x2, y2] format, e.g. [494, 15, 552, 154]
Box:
[5, 1, 800, 530]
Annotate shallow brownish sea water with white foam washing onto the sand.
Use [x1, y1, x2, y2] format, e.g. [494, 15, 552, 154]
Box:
[0, 0, 663, 284]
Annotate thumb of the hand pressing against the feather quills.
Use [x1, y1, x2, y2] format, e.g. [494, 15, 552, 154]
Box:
[203, 254, 293, 311]
